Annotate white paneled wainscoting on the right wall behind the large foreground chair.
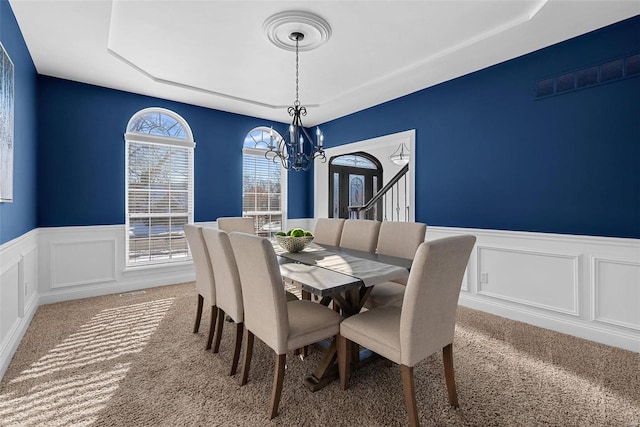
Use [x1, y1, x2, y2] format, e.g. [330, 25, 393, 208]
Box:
[426, 227, 640, 352]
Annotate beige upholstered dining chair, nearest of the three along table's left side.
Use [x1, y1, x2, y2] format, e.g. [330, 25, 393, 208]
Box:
[229, 233, 342, 419]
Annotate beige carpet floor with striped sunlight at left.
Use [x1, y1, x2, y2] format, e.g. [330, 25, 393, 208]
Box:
[0, 284, 640, 427]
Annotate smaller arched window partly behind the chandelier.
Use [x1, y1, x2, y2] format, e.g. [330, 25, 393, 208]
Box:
[242, 127, 287, 237]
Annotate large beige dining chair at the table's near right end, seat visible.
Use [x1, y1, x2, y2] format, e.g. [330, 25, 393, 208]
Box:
[337, 236, 476, 426]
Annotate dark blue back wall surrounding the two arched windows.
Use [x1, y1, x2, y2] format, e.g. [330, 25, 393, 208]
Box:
[38, 76, 310, 227]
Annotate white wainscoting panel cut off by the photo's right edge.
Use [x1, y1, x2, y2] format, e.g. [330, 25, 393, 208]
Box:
[592, 257, 640, 331]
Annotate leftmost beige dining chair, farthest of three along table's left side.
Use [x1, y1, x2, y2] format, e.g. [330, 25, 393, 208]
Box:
[184, 224, 218, 350]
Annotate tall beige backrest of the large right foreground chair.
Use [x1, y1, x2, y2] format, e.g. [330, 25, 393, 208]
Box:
[400, 236, 476, 366]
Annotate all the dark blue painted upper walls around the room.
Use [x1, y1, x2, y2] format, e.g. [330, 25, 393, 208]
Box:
[0, 0, 640, 244]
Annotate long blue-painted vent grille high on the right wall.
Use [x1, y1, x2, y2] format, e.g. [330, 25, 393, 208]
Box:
[535, 53, 640, 98]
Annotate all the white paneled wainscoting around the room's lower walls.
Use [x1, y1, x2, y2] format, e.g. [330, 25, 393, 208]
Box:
[0, 222, 640, 376]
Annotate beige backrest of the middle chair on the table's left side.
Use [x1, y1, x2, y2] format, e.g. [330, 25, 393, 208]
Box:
[202, 228, 244, 323]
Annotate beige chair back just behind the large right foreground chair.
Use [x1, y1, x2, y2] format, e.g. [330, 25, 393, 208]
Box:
[377, 221, 427, 259]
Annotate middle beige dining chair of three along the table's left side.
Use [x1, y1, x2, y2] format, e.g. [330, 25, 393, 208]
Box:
[202, 228, 244, 375]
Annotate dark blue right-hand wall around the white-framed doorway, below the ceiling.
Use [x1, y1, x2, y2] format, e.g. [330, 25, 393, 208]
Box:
[322, 17, 640, 238]
